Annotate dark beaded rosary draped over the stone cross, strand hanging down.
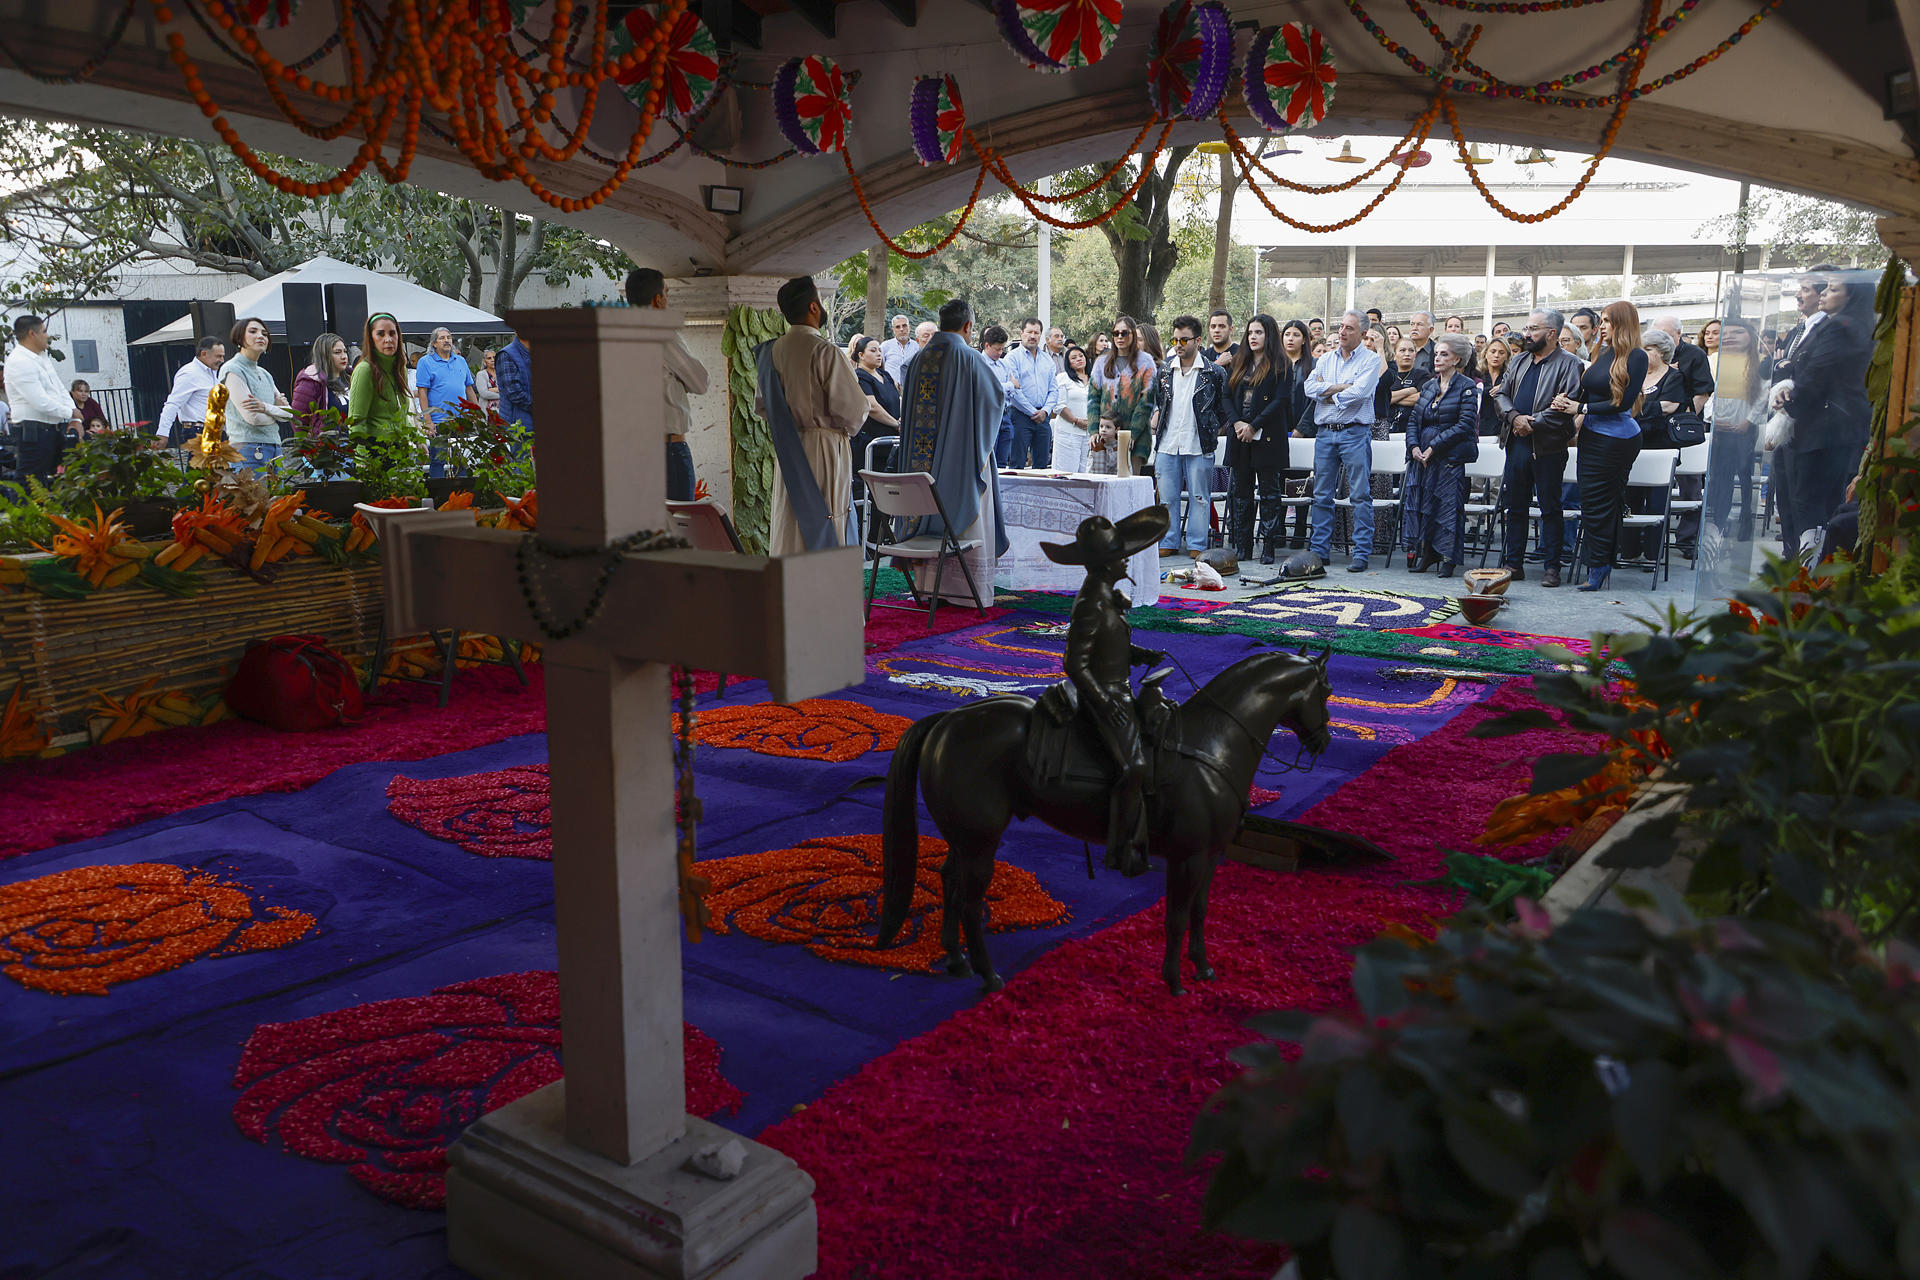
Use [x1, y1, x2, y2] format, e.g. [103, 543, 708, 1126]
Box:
[515, 530, 712, 942]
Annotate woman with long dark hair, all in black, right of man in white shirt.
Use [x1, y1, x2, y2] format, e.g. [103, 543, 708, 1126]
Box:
[1227, 315, 1294, 564]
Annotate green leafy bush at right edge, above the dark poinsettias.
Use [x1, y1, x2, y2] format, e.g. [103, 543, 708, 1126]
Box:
[1476, 560, 1920, 938]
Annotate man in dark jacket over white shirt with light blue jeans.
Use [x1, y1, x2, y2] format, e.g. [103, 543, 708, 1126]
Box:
[1154, 315, 1227, 560]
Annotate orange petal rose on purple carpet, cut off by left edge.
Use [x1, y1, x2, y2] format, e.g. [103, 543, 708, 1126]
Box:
[0, 862, 315, 996]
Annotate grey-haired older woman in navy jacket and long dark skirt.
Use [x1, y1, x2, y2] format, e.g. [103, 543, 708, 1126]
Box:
[1402, 334, 1480, 578]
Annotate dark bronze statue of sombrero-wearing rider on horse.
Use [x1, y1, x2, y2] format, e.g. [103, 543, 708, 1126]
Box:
[879, 507, 1331, 996]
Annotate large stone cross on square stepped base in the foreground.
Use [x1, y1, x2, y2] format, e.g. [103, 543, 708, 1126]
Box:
[384, 309, 866, 1280]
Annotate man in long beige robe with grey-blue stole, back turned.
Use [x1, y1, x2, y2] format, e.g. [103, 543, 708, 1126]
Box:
[755, 276, 866, 555]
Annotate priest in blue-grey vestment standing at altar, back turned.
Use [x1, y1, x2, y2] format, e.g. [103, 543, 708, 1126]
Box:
[895, 297, 1006, 606]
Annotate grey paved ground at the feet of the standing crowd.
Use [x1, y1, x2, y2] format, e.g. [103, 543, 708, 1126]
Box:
[1160, 541, 1780, 637]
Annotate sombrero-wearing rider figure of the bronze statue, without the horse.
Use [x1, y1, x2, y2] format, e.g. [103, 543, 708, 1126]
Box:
[1041, 507, 1171, 875]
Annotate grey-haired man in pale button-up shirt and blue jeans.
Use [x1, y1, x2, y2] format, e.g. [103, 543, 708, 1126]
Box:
[1306, 311, 1382, 574]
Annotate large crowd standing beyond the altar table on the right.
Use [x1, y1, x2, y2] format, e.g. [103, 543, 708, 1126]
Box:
[817, 267, 1874, 591]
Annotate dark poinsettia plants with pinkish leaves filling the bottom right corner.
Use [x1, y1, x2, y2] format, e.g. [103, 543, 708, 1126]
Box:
[1192, 902, 1920, 1280]
